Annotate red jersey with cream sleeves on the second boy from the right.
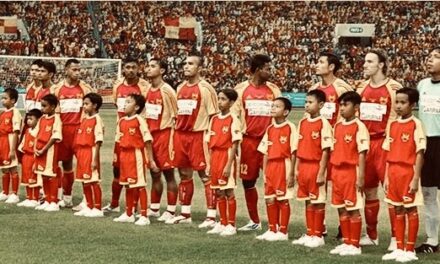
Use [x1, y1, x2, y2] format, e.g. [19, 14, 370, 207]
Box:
[330, 118, 370, 166]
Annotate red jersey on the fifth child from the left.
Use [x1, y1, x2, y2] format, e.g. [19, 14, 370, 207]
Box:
[115, 115, 153, 149]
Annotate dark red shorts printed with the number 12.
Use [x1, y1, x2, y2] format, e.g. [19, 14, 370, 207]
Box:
[240, 136, 264, 181]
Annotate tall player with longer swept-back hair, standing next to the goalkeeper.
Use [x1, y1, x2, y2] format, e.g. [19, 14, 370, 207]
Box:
[357, 50, 402, 250]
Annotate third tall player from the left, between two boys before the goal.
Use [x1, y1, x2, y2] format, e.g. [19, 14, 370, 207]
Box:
[54, 59, 92, 207]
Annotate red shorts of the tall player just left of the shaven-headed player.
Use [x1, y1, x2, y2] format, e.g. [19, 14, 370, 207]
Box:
[151, 128, 173, 170]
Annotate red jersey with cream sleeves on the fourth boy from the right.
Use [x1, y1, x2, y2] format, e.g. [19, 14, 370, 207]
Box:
[258, 121, 297, 160]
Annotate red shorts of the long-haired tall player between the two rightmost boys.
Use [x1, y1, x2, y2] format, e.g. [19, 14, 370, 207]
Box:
[364, 137, 386, 189]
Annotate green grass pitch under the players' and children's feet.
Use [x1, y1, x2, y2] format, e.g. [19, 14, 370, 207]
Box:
[0, 110, 439, 264]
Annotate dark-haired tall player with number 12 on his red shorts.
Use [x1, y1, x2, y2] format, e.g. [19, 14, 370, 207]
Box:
[234, 54, 281, 231]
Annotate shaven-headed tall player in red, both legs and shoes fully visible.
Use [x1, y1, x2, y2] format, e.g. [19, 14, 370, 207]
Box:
[165, 53, 218, 228]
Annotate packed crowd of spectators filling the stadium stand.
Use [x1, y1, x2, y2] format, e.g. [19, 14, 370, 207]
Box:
[0, 1, 440, 91]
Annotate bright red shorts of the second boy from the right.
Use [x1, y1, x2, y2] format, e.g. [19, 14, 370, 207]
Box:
[332, 164, 361, 210]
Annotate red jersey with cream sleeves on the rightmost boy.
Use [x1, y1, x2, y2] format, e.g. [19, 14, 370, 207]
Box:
[382, 116, 426, 165]
